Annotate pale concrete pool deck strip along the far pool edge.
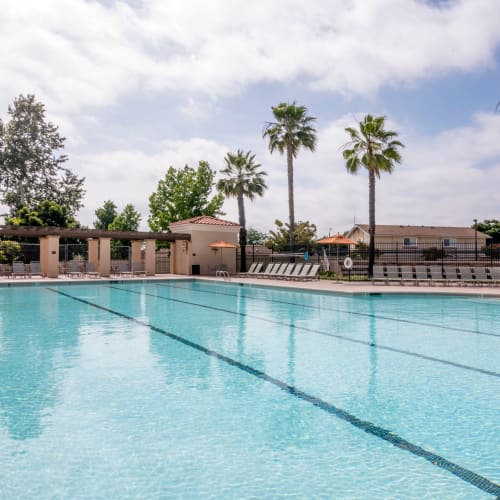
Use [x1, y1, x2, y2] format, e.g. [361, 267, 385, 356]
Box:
[0, 274, 500, 298]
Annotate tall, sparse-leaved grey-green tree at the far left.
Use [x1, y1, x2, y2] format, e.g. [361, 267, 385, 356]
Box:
[0, 94, 85, 215]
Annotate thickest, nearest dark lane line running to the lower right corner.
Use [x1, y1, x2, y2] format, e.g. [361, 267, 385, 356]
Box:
[47, 288, 500, 496]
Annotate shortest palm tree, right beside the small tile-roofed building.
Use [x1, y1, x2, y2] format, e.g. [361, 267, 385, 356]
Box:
[217, 149, 267, 272]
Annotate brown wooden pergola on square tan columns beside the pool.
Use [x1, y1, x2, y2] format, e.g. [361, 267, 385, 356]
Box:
[0, 226, 191, 278]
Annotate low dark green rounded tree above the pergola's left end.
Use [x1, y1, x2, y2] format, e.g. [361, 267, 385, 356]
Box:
[6, 200, 79, 227]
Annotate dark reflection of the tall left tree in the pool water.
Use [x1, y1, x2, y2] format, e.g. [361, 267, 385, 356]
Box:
[0, 289, 78, 439]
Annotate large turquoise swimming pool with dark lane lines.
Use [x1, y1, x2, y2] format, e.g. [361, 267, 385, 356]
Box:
[0, 280, 500, 499]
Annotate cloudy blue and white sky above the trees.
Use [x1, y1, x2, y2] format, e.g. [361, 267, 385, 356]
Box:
[0, 0, 500, 237]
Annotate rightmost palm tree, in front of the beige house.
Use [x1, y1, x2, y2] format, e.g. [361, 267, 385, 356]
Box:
[343, 115, 404, 277]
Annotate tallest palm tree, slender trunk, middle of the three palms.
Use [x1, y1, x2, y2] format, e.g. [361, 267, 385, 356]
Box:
[263, 101, 316, 252]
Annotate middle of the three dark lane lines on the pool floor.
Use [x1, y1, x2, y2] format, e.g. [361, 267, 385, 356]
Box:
[108, 285, 500, 378]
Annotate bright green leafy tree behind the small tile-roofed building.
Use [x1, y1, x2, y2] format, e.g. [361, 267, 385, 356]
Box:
[148, 161, 224, 231]
